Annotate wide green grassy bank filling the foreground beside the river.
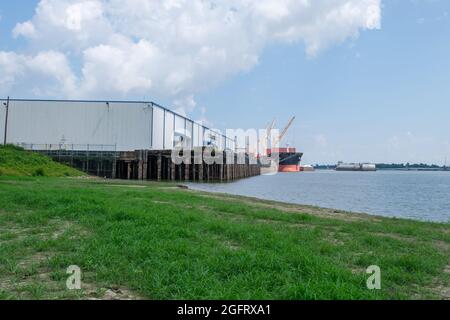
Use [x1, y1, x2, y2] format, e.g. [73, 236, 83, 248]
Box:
[0, 177, 450, 299]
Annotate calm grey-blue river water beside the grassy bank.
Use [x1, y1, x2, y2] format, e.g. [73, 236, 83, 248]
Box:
[189, 170, 450, 222]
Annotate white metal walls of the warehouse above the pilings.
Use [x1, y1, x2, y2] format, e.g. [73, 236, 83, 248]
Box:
[0, 100, 236, 151]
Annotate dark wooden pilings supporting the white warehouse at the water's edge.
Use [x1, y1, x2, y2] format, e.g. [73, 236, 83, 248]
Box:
[37, 148, 261, 182]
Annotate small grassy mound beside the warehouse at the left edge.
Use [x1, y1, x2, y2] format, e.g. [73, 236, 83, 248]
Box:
[0, 145, 83, 177]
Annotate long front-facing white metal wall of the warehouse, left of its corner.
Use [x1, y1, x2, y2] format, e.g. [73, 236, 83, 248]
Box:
[8, 101, 152, 151]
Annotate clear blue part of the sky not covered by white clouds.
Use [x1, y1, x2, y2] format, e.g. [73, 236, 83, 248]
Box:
[0, 0, 450, 164]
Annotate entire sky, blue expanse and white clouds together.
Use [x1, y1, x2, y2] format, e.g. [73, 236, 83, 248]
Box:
[0, 0, 450, 164]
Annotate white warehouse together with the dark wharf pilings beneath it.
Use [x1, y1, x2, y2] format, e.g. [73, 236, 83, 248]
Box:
[0, 99, 261, 182]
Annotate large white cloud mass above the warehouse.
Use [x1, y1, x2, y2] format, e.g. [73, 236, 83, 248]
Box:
[0, 0, 381, 112]
